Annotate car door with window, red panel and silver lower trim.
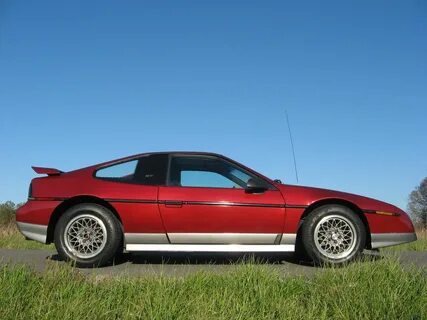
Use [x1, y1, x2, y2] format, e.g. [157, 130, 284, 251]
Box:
[158, 154, 285, 244]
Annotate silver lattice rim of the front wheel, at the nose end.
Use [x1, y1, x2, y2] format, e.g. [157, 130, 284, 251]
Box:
[314, 215, 357, 260]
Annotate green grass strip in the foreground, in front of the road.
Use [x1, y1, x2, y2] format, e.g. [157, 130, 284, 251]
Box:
[0, 259, 427, 320]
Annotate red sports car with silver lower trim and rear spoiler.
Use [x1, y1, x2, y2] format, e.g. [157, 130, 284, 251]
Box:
[16, 152, 416, 267]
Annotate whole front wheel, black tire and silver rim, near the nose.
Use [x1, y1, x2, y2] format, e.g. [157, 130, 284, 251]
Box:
[301, 205, 366, 265]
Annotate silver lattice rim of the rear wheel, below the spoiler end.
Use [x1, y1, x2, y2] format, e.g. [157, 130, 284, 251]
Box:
[64, 214, 107, 259]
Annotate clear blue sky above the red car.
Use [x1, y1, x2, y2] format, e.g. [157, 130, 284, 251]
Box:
[0, 0, 427, 208]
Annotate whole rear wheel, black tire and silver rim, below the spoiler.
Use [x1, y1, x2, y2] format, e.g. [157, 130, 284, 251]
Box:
[54, 203, 123, 268]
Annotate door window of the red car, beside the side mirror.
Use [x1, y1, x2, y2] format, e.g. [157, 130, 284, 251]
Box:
[169, 156, 269, 189]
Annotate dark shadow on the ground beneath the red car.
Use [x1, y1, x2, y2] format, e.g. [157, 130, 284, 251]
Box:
[47, 251, 383, 268]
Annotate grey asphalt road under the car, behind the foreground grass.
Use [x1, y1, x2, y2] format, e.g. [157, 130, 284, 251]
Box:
[0, 249, 427, 278]
